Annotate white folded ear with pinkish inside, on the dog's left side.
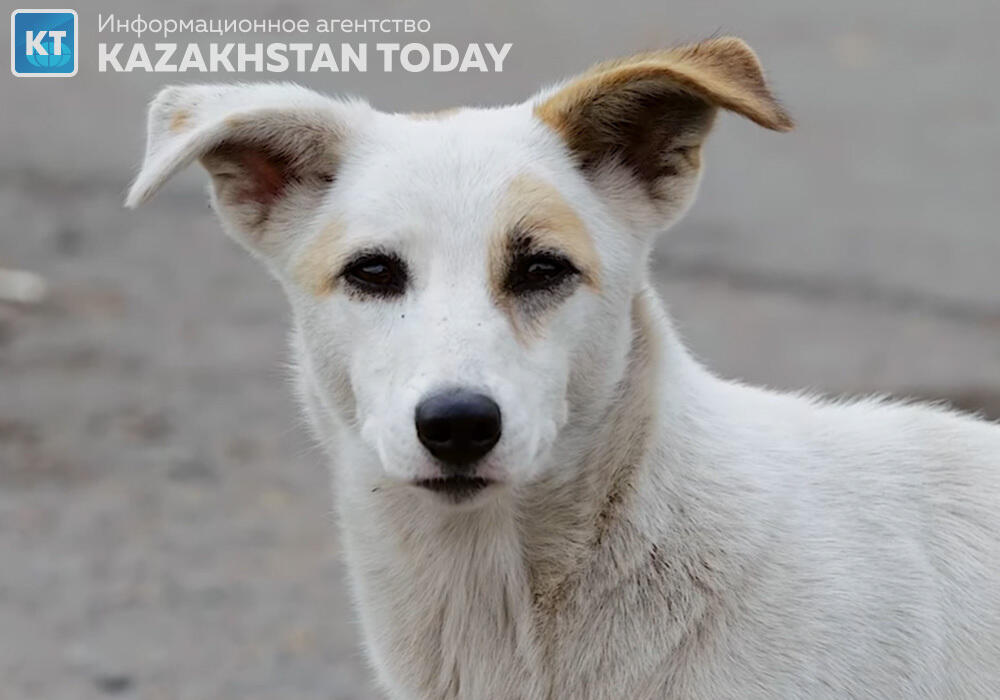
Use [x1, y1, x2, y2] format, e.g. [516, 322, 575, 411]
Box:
[125, 84, 370, 254]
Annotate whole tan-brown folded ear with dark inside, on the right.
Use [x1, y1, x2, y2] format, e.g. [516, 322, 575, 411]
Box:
[534, 37, 793, 208]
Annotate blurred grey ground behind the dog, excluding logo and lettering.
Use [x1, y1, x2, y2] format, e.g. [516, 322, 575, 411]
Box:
[0, 0, 1000, 700]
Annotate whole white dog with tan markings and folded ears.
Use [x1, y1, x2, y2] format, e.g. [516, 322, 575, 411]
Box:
[126, 37, 1000, 700]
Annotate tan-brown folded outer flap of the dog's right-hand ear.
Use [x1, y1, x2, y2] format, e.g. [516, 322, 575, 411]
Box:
[535, 37, 794, 137]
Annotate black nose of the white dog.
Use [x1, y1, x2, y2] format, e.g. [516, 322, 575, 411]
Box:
[416, 389, 500, 473]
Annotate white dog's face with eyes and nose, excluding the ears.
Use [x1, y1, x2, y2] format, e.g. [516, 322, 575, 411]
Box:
[286, 117, 612, 486]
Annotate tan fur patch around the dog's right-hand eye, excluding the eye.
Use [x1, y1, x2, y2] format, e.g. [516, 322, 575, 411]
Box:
[489, 174, 600, 343]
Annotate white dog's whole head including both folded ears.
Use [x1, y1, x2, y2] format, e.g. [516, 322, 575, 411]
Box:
[127, 38, 791, 504]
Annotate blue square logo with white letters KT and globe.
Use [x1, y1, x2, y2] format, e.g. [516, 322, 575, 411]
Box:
[10, 10, 79, 78]
